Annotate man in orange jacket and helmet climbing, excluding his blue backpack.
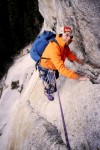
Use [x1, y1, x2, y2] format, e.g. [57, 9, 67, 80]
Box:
[38, 26, 87, 101]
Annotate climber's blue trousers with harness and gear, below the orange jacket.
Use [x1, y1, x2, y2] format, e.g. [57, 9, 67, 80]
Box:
[38, 65, 59, 94]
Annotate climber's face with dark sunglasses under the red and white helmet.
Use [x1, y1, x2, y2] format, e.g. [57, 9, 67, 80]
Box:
[62, 31, 73, 45]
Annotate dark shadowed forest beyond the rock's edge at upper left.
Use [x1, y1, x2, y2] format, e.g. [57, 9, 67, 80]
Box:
[0, 0, 43, 78]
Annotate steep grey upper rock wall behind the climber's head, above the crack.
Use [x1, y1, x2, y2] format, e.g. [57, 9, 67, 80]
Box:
[39, 0, 100, 77]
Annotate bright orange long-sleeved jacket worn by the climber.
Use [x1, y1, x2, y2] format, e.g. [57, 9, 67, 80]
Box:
[40, 35, 78, 79]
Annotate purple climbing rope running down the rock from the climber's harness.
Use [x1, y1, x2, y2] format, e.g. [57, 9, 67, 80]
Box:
[56, 84, 71, 150]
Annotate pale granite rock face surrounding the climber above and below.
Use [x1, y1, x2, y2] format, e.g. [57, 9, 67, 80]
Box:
[0, 0, 100, 150]
